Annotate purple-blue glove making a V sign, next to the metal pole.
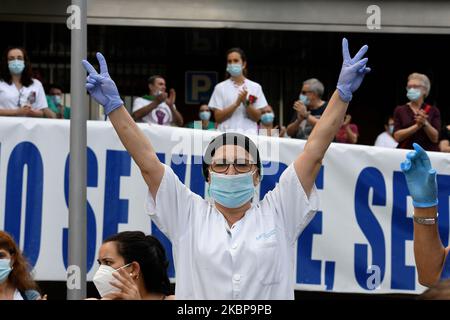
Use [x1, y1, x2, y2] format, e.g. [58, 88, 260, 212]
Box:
[82, 52, 123, 115]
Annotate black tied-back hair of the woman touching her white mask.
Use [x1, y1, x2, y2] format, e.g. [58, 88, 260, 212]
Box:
[103, 231, 170, 295]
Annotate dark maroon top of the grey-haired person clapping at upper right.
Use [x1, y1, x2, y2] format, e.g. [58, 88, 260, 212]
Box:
[394, 104, 441, 151]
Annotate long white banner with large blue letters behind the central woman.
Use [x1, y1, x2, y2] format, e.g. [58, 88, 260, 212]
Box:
[0, 117, 450, 293]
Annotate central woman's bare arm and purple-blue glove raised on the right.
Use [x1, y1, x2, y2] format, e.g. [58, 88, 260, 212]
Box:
[294, 38, 370, 196]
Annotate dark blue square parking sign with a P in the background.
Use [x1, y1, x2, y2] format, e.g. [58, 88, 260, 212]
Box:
[185, 71, 217, 104]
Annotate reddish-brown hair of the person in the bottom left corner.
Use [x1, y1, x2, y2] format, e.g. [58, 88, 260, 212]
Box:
[0, 231, 38, 292]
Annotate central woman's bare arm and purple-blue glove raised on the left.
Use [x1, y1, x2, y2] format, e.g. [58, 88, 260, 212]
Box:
[83, 53, 164, 198]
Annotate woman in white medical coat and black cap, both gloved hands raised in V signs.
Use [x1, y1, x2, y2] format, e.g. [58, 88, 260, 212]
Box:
[83, 39, 370, 299]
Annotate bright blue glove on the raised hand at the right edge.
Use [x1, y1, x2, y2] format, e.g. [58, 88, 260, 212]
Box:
[400, 143, 438, 208]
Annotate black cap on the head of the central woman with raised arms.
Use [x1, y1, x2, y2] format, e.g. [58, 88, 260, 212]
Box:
[203, 132, 262, 180]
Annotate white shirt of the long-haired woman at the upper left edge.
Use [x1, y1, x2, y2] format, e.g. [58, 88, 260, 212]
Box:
[0, 79, 48, 110]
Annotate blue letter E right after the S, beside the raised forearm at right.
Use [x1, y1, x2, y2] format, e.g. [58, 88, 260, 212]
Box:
[391, 171, 416, 290]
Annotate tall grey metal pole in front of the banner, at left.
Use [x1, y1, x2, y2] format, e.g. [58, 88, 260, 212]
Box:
[67, 0, 87, 300]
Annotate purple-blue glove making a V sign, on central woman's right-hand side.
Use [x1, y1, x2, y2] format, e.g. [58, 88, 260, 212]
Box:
[336, 38, 370, 102]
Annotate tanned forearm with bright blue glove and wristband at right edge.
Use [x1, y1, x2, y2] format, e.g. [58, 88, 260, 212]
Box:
[400, 143, 448, 286]
